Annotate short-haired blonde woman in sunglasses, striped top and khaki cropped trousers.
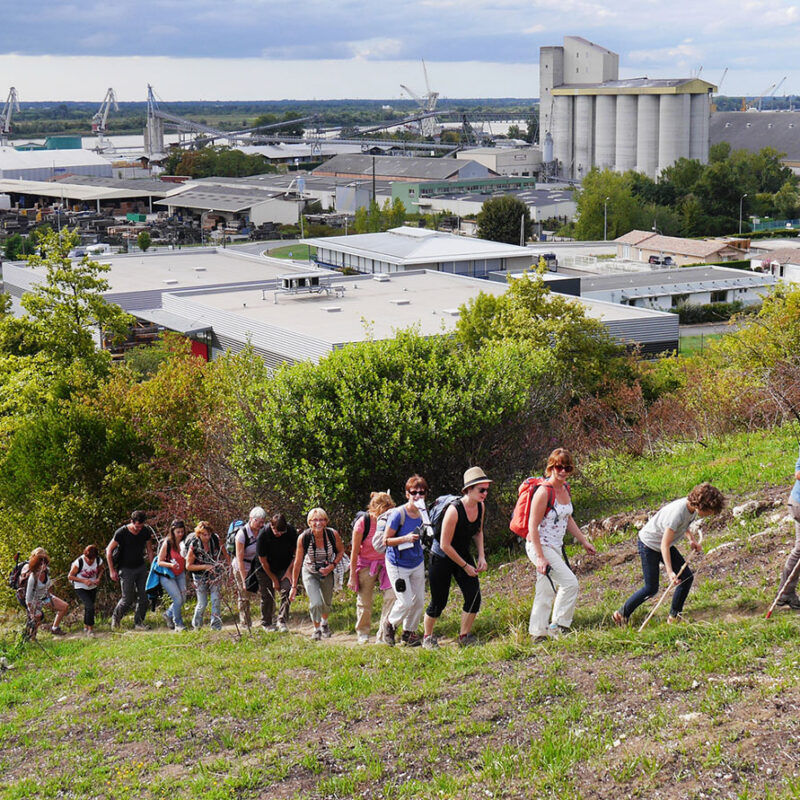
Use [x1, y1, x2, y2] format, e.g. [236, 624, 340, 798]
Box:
[289, 508, 344, 641]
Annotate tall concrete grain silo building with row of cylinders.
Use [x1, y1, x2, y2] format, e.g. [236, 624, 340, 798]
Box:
[539, 36, 716, 180]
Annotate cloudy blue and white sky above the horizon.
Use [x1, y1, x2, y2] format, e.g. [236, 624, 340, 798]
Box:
[0, 0, 800, 103]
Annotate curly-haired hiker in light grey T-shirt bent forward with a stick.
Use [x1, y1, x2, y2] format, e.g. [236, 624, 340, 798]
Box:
[613, 483, 725, 625]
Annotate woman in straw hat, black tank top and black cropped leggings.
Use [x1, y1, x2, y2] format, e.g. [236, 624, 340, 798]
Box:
[422, 467, 492, 650]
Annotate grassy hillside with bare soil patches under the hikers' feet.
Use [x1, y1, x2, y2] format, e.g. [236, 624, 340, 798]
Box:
[0, 422, 800, 800]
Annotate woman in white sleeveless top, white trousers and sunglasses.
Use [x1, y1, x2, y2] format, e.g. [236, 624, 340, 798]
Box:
[525, 447, 597, 641]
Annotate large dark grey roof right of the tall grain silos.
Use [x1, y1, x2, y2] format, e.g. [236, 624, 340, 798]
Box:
[709, 111, 800, 161]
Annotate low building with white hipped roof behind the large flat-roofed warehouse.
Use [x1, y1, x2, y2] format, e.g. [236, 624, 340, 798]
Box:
[303, 227, 536, 278]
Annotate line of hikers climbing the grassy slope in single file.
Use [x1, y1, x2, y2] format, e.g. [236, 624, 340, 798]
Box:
[17, 448, 800, 649]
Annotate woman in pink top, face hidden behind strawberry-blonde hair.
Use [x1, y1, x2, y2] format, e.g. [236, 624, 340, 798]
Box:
[347, 492, 395, 644]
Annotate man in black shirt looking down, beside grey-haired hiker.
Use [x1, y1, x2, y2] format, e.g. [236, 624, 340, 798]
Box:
[256, 514, 297, 633]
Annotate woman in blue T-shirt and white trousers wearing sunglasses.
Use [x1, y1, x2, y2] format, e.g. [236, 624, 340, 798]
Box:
[381, 475, 428, 647]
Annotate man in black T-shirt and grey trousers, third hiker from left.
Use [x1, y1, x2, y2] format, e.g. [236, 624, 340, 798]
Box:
[106, 511, 155, 630]
